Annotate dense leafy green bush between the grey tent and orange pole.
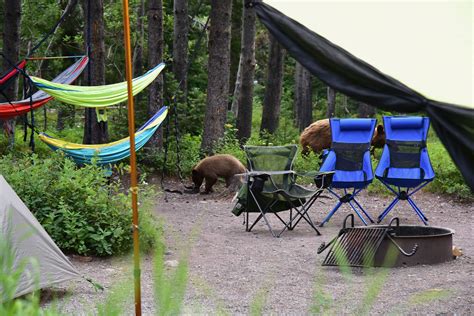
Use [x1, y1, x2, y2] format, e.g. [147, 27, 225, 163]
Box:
[0, 153, 159, 256]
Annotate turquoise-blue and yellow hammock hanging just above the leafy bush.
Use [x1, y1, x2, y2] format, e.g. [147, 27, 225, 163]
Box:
[39, 107, 168, 165]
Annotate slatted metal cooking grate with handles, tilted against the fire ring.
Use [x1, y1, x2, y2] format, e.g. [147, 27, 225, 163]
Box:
[318, 214, 417, 267]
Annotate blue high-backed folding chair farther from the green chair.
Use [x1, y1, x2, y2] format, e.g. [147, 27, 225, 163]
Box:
[375, 116, 435, 225]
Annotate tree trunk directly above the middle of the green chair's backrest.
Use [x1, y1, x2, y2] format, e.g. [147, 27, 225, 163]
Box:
[260, 36, 285, 134]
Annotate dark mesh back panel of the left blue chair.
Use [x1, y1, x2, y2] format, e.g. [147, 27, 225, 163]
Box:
[332, 142, 370, 171]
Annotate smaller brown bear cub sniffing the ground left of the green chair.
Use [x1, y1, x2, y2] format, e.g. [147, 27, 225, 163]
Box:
[192, 154, 247, 194]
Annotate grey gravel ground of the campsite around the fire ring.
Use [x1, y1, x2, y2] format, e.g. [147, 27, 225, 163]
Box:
[44, 183, 474, 315]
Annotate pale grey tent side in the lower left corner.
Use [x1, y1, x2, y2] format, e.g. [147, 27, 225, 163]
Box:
[0, 175, 81, 301]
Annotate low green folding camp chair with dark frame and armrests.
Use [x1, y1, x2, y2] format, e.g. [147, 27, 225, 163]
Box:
[232, 145, 332, 237]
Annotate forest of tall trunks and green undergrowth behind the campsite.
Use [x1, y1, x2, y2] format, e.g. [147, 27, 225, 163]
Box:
[0, 0, 472, 255]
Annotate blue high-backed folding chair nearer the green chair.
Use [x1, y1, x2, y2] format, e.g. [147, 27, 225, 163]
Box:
[320, 119, 376, 226]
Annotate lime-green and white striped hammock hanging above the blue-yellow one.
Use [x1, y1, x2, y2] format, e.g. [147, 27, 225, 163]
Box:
[31, 63, 165, 108]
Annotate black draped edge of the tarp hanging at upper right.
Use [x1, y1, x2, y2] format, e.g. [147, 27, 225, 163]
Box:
[252, 1, 474, 191]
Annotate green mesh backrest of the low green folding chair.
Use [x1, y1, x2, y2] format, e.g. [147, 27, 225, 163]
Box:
[244, 145, 298, 190]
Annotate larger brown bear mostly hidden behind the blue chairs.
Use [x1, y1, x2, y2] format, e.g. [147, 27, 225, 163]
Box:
[300, 119, 385, 156]
